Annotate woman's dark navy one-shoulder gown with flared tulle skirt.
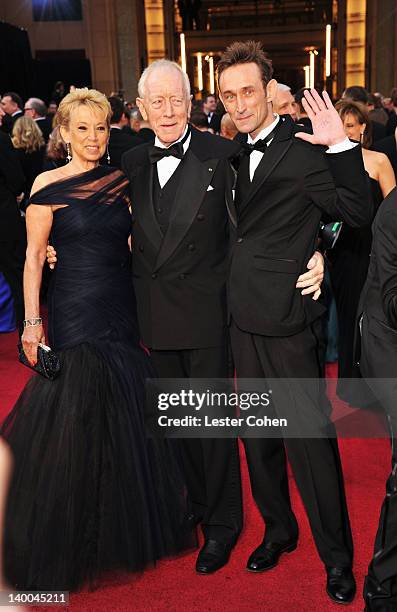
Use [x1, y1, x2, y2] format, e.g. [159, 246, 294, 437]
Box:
[1, 166, 195, 591]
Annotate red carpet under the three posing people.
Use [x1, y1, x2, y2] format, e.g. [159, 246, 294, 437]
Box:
[0, 334, 390, 612]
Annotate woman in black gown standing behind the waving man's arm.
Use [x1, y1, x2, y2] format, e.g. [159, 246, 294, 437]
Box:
[328, 100, 396, 406]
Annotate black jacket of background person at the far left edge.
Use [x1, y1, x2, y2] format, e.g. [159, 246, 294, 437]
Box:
[0, 132, 25, 242]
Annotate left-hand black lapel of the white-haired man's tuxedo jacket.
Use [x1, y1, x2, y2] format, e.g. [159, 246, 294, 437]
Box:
[132, 159, 163, 252]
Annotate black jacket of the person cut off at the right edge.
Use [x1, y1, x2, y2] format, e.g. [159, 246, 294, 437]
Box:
[356, 188, 397, 380]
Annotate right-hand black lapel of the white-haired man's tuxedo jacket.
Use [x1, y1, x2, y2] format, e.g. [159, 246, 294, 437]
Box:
[156, 146, 218, 269]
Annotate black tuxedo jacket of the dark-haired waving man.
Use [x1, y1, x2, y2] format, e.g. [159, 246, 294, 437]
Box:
[228, 116, 373, 336]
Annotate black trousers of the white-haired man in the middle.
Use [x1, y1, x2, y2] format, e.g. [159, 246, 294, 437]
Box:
[151, 346, 242, 542]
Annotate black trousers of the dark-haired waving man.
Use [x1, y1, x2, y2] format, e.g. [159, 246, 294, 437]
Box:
[231, 321, 353, 567]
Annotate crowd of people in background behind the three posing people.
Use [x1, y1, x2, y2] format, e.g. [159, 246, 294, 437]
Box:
[0, 81, 397, 360]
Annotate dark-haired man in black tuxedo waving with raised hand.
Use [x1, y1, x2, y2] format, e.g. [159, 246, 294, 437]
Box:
[218, 41, 372, 603]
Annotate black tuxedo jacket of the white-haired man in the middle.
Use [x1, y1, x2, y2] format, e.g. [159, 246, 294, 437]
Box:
[122, 128, 239, 349]
